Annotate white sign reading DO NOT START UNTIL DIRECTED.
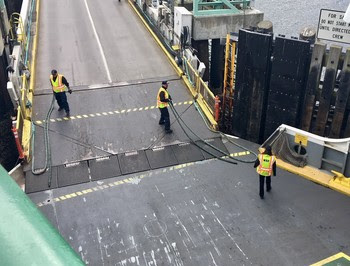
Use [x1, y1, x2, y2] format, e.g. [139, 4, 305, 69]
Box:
[317, 9, 350, 44]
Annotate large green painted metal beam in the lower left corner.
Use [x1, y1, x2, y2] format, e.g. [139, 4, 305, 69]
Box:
[0, 165, 85, 266]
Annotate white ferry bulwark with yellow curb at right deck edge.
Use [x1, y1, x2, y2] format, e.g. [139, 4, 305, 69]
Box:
[261, 124, 350, 196]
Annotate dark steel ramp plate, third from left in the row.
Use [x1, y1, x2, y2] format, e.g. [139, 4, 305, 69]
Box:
[89, 156, 122, 181]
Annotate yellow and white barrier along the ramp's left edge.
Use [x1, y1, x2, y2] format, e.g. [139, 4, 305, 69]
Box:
[7, 0, 39, 160]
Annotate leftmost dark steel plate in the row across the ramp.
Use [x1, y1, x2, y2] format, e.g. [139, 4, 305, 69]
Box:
[25, 166, 57, 193]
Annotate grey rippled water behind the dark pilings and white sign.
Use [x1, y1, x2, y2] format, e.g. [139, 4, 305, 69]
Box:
[255, 0, 350, 37]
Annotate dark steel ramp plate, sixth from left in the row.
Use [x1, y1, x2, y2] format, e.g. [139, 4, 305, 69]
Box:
[172, 143, 204, 164]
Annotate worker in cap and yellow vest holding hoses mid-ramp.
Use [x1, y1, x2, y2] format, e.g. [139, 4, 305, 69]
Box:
[157, 81, 173, 134]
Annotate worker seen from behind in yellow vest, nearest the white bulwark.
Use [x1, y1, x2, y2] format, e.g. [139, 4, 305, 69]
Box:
[254, 145, 276, 199]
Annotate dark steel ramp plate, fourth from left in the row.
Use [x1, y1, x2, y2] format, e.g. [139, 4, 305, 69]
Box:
[118, 150, 150, 175]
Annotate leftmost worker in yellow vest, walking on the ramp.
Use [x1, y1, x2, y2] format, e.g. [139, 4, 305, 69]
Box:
[50, 69, 72, 117]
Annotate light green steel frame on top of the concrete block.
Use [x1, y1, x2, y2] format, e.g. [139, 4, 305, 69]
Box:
[193, 0, 250, 16]
